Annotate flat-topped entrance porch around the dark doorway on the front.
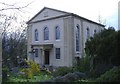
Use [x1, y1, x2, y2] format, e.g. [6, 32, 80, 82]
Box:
[29, 44, 53, 67]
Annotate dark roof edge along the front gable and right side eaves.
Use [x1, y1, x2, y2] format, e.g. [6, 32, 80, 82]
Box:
[27, 7, 105, 27]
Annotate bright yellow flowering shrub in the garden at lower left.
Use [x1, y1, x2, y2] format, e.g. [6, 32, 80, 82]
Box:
[21, 60, 40, 78]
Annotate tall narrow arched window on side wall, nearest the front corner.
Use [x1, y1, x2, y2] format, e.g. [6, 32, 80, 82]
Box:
[76, 25, 80, 51]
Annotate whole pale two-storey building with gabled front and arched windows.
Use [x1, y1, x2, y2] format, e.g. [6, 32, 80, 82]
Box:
[27, 7, 104, 67]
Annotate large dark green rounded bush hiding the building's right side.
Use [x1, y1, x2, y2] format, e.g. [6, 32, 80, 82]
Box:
[85, 28, 120, 65]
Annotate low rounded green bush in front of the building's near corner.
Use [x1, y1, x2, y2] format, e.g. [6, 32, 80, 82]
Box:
[52, 67, 73, 77]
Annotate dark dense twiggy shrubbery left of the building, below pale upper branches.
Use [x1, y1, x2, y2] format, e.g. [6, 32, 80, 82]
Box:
[2, 29, 27, 68]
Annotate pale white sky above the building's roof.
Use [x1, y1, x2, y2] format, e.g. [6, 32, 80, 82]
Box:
[0, 0, 120, 29]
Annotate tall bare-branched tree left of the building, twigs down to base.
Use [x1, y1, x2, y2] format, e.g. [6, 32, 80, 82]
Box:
[0, 2, 32, 71]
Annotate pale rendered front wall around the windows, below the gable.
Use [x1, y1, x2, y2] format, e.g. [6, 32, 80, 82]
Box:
[32, 18, 64, 66]
